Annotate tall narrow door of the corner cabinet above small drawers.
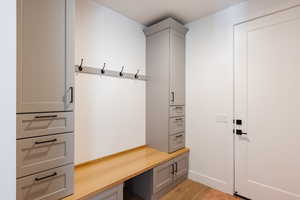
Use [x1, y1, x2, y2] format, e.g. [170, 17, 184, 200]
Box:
[170, 30, 185, 105]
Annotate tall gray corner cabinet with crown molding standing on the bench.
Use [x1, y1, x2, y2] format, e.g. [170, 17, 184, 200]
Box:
[144, 18, 188, 153]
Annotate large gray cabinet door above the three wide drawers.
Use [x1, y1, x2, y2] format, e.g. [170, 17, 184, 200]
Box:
[17, 0, 74, 113]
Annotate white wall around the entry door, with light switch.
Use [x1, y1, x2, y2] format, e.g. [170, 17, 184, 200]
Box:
[186, 0, 299, 193]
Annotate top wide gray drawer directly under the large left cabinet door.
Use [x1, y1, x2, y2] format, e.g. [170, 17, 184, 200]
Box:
[17, 112, 74, 139]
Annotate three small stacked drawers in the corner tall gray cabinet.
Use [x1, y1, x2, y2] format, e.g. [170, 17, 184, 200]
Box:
[169, 106, 185, 153]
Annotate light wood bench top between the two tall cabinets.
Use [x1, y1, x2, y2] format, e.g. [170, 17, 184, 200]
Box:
[63, 146, 189, 200]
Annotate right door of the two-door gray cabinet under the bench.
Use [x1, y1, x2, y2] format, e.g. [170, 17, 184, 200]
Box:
[174, 153, 189, 180]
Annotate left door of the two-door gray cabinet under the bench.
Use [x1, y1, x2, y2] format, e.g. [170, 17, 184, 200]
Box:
[153, 161, 175, 194]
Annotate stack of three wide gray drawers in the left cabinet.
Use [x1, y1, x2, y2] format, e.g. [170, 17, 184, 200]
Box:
[17, 112, 74, 200]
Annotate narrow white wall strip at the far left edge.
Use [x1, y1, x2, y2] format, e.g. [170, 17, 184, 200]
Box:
[0, 1, 16, 200]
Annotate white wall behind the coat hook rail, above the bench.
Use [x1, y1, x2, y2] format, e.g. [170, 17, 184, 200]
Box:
[75, 0, 145, 164]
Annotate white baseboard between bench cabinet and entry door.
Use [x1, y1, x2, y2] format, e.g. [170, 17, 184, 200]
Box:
[188, 170, 233, 194]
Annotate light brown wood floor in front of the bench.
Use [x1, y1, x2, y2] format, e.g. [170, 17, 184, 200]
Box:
[160, 180, 239, 200]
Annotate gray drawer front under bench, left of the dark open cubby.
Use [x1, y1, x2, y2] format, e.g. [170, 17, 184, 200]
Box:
[89, 184, 123, 200]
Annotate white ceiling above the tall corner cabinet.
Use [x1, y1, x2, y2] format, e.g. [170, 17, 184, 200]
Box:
[95, 0, 244, 26]
